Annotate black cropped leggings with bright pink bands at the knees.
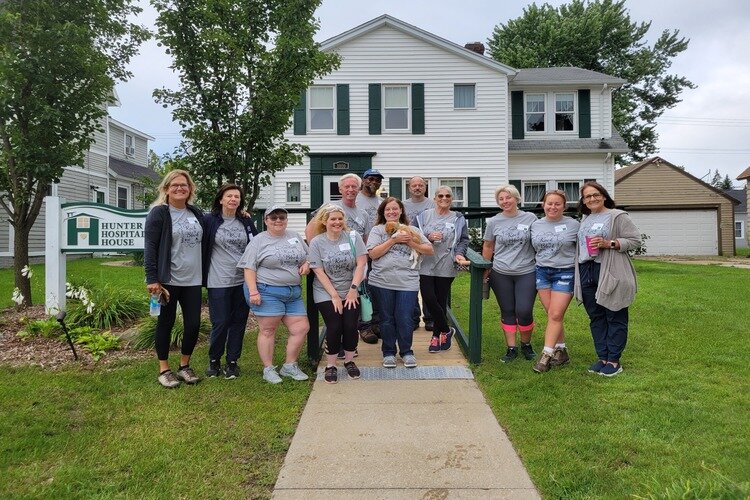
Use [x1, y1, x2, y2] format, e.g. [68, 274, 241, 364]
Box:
[490, 270, 536, 332]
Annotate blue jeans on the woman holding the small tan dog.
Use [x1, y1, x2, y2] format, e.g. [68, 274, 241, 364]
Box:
[370, 285, 417, 357]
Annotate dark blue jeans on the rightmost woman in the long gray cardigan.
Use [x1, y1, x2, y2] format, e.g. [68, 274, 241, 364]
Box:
[578, 261, 628, 363]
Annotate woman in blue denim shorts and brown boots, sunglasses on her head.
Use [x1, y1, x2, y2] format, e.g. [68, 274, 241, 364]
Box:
[531, 190, 580, 373]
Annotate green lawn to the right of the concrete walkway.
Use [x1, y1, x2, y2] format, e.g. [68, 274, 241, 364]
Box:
[453, 261, 750, 498]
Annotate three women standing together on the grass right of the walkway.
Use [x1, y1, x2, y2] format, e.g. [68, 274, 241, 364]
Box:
[482, 181, 641, 377]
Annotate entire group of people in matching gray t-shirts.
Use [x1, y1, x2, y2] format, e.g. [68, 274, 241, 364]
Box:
[144, 169, 640, 388]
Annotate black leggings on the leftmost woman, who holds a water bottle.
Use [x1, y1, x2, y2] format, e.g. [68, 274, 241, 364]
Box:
[156, 285, 201, 361]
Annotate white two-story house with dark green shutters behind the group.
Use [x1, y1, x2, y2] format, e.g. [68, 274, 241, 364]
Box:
[258, 15, 628, 230]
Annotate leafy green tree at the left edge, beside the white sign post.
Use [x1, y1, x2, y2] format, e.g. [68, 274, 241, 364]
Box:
[0, 0, 149, 307]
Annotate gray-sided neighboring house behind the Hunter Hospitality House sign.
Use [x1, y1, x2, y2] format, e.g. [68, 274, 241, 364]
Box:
[0, 95, 158, 267]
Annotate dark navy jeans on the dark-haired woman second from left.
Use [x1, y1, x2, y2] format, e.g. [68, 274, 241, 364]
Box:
[208, 285, 250, 363]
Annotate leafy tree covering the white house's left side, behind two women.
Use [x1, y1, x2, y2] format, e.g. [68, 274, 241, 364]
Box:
[152, 0, 339, 208]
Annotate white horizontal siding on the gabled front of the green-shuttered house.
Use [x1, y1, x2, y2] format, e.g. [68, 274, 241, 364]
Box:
[280, 27, 508, 215]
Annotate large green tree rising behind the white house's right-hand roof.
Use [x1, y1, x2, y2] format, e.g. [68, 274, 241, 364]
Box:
[488, 0, 695, 165]
